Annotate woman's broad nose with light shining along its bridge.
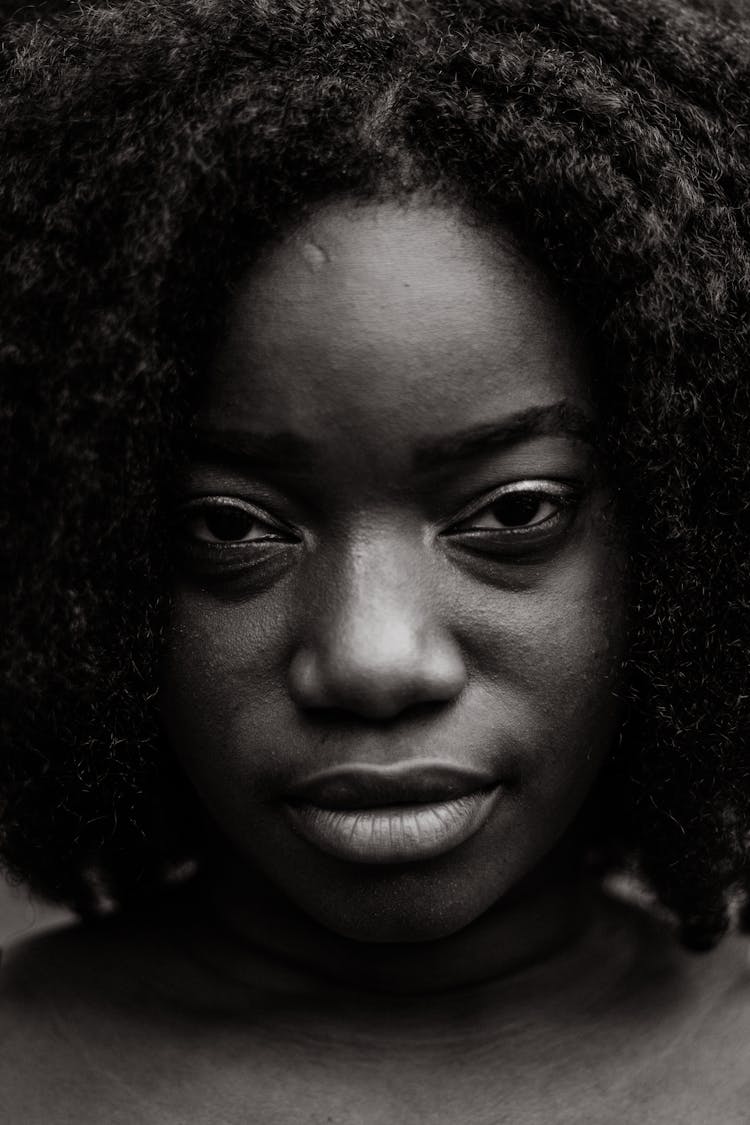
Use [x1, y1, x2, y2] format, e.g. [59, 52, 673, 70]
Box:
[289, 533, 467, 721]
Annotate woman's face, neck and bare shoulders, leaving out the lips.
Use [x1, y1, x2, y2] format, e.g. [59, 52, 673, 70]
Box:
[0, 200, 750, 1125]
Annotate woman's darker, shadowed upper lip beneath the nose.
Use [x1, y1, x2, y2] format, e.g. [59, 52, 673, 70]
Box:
[286, 762, 497, 809]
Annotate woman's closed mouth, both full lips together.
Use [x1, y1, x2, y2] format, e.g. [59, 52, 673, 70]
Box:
[284, 763, 500, 864]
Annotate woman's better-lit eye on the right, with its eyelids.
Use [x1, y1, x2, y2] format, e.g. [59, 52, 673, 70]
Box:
[449, 480, 580, 552]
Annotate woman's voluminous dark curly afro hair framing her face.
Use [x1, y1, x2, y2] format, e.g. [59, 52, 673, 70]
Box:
[0, 0, 750, 948]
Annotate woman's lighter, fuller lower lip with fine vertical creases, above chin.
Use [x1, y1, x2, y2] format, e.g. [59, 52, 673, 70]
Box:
[287, 785, 498, 863]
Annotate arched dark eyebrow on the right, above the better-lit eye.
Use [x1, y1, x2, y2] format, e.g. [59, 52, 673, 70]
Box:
[415, 399, 596, 470]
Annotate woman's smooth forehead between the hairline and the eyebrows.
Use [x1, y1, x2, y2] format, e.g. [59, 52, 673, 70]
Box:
[201, 200, 588, 446]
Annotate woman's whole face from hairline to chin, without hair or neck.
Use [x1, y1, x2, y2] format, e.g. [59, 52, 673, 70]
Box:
[163, 201, 623, 942]
